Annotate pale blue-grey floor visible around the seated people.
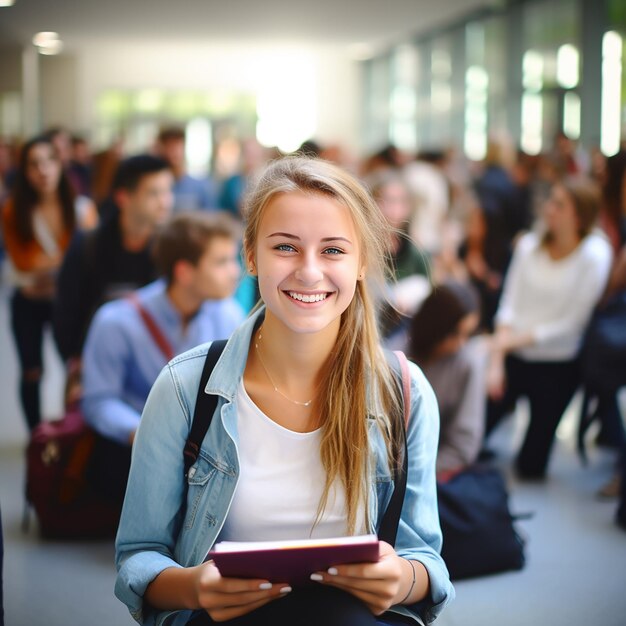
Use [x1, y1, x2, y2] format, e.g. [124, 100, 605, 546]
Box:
[0, 282, 626, 626]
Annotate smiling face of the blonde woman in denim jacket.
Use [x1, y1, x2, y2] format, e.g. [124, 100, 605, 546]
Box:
[247, 192, 363, 333]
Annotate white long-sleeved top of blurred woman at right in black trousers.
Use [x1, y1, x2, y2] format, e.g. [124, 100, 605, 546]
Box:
[496, 232, 612, 361]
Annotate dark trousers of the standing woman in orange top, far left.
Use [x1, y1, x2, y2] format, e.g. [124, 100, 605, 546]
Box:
[11, 290, 52, 430]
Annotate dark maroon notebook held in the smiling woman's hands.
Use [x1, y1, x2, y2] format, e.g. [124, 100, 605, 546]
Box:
[207, 535, 378, 585]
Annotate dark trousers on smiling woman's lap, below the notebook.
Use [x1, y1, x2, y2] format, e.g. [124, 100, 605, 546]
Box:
[187, 585, 415, 626]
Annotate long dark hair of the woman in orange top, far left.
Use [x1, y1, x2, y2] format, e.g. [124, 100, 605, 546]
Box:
[12, 136, 76, 243]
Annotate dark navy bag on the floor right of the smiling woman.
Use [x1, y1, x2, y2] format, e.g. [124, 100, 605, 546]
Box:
[437, 465, 525, 580]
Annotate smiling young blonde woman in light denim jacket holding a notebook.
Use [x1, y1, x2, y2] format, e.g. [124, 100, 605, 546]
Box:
[116, 158, 454, 626]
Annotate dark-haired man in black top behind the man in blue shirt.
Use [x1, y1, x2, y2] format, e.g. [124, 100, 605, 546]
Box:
[53, 155, 173, 363]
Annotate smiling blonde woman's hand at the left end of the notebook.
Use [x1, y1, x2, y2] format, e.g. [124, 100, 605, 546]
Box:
[195, 561, 291, 622]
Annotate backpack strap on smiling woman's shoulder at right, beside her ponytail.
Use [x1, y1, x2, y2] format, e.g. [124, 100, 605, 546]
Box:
[378, 351, 411, 546]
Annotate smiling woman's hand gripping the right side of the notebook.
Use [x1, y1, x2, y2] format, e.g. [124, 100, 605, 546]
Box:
[311, 541, 411, 615]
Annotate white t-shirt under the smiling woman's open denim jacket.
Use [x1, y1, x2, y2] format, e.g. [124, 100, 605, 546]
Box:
[219, 379, 363, 541]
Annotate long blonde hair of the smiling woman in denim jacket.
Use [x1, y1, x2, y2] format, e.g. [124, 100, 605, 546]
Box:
[244, 157, 403, 534]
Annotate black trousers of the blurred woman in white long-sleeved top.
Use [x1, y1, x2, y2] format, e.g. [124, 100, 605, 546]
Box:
[486, 356, 580, 478]
